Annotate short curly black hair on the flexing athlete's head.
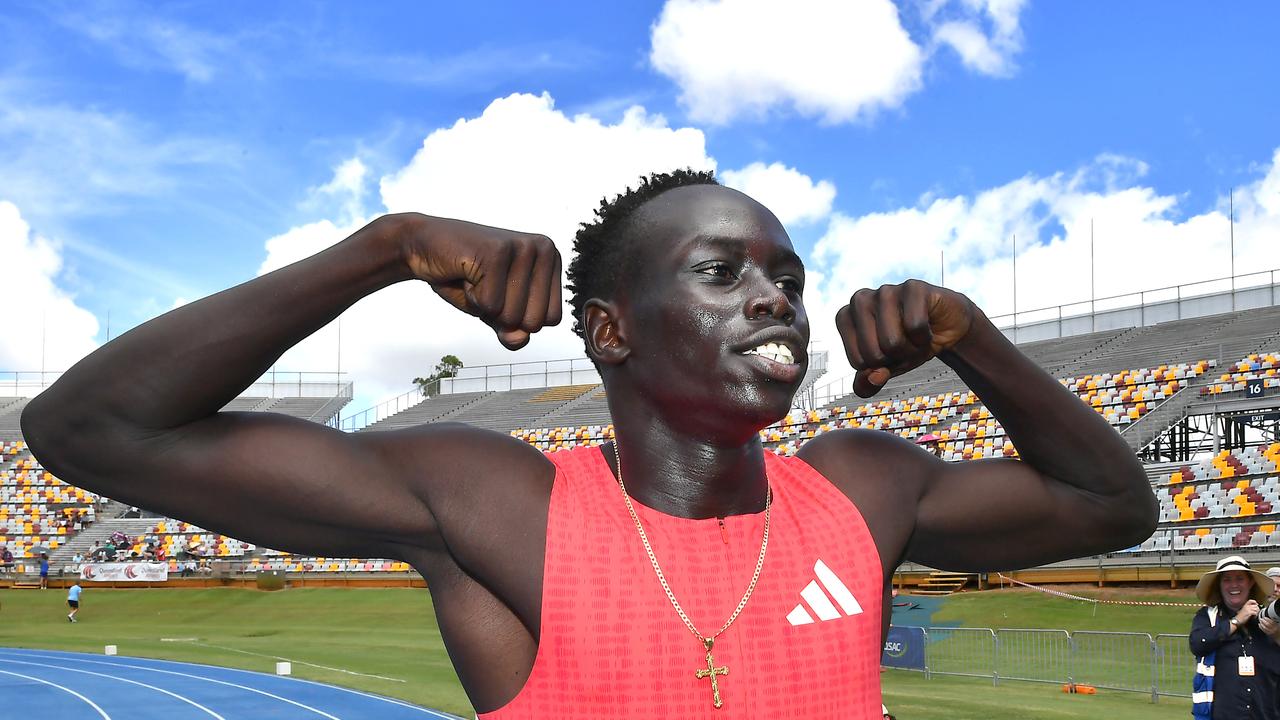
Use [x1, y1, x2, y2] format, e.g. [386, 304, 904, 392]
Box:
[566, 168, 719, 340]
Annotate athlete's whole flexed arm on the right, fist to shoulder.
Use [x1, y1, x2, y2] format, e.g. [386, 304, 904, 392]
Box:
[819, 281, 1158, 570]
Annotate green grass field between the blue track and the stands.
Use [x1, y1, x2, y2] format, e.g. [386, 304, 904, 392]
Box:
[0, 585, 1192, 720]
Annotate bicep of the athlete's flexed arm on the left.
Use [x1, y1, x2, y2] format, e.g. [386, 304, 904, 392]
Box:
[118, 413, 509, 557]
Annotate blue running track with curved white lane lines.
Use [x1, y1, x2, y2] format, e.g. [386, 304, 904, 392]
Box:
[0, 648, 457, 720]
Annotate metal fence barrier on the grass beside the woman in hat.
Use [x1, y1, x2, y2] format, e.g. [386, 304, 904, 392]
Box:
[922, 628, 1196, 702]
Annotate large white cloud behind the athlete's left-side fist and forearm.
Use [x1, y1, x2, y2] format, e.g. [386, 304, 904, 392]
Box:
[260, 95, 716, 410]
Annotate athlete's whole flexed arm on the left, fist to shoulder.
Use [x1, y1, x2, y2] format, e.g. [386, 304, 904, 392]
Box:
[22, 214, 561, 557]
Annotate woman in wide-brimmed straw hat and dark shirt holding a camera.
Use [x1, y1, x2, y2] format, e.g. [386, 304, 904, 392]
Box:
[1188, 555, 1280, 720]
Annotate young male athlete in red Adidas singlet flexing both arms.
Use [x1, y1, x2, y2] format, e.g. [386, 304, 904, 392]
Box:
[22, 172, 1156, 720]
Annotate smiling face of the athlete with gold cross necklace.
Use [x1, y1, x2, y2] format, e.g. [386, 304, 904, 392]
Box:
[617, 186, 809, 434]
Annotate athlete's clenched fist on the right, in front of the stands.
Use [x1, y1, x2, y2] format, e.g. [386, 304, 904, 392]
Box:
[836, 281, 978, 397]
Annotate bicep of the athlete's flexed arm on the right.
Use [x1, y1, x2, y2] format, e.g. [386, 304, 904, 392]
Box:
[908, 459, 1110, 571]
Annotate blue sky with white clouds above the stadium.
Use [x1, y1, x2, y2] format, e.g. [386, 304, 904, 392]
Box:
[0, 0, 1280, 400]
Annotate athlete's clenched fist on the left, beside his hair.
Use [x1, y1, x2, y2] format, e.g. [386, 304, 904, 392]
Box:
[402, 215, 562, 350]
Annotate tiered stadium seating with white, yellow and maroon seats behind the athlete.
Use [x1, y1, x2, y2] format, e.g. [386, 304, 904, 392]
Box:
[0, 301, 1280, 573]
